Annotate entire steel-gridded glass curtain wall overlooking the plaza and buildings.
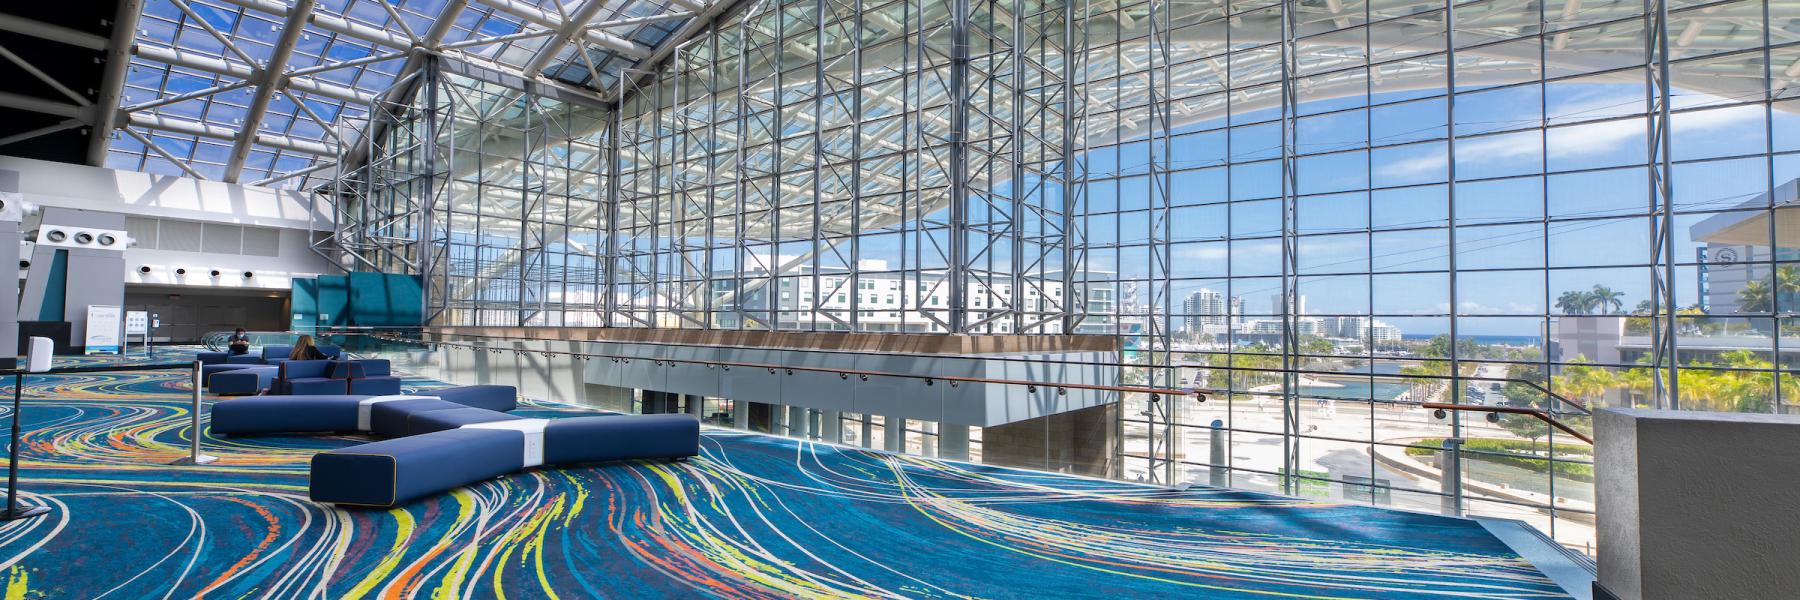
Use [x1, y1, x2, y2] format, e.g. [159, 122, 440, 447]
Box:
[338, 0, 1800, 548]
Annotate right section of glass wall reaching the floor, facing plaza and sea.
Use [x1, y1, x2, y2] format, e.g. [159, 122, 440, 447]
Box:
[1076, 0, 1800, 548]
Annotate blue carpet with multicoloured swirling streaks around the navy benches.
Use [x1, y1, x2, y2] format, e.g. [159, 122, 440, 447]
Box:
[0, 347, 1562, 598]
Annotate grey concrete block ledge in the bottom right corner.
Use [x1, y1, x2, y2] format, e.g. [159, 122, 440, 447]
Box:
[1595, 409, 1800, 600]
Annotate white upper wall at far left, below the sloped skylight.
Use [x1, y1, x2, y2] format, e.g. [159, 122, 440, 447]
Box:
[0, 157, 340, 290]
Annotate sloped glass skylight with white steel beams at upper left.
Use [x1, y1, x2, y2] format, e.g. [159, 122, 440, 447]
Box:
[108, 0, 709, 187]
